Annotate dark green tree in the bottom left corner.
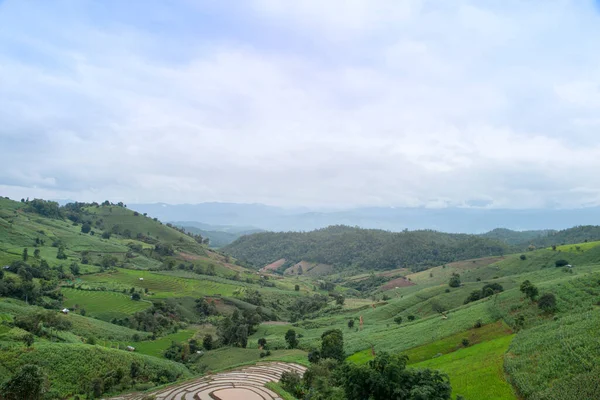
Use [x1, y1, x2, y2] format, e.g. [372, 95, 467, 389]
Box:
[0, 364, 47, 400]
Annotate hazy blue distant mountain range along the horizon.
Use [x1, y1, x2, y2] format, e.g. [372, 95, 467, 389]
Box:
[129, 203, 600, 233]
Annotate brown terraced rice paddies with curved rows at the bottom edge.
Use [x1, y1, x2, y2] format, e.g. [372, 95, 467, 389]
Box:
[114, 362, 306, 400]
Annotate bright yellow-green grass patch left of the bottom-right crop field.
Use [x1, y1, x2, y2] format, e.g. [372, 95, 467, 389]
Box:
[411, 335, 517, 400]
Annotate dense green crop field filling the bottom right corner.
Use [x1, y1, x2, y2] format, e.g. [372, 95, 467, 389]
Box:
[506, 273, 600, 400]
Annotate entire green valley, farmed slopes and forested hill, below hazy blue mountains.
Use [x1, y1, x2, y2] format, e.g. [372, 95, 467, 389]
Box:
[0, 198, 600, 400]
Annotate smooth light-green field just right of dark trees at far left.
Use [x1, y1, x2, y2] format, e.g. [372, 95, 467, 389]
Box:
[62, 288, 152, 320]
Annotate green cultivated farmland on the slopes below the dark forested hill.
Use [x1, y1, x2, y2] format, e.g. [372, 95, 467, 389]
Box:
[0, 199, 600, 400]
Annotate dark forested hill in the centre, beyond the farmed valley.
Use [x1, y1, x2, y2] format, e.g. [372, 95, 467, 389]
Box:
[223, 225, 510, 270]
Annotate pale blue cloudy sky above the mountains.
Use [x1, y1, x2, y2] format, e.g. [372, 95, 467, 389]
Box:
[0, 0, 600, 209]
